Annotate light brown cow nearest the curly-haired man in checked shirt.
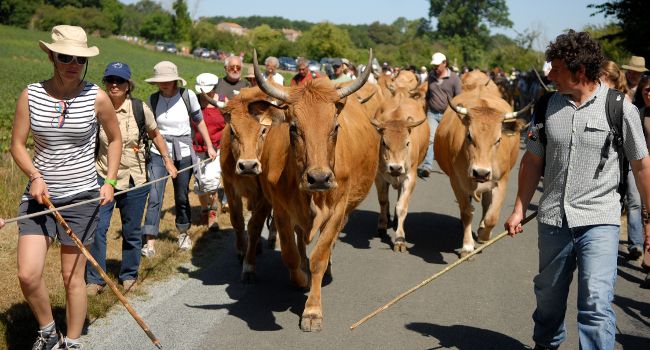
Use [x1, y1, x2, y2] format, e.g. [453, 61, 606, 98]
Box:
[434, 88, 525, 257]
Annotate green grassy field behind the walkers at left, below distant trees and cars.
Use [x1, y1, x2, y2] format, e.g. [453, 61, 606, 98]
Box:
[0, 25, 228, 152]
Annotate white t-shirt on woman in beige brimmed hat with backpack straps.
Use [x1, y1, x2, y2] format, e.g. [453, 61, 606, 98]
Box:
[149, 90, 201, 157]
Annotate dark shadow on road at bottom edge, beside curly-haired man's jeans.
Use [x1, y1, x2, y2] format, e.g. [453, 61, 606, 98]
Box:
[406, 322, 530, 350]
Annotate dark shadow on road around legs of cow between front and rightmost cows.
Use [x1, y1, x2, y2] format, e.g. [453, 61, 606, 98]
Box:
[340, 210, 463, 264]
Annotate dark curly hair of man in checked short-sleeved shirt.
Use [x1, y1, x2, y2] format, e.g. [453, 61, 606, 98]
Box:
[546, 29, 605, 80]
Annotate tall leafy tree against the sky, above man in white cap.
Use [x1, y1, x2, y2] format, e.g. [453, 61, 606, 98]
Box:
[429, 0, 512, 37]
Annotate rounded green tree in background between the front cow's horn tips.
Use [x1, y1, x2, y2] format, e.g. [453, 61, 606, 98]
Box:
[298, 22, 353, 58]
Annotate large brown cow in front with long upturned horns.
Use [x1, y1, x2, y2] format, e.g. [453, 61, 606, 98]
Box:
[253, 52, 379, 331]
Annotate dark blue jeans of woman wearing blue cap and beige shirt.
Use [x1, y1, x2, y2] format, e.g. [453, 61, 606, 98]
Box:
[86, 176, 149, 285]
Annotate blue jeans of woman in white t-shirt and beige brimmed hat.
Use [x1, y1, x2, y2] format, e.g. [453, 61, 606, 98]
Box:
[142, 153, 192, 237]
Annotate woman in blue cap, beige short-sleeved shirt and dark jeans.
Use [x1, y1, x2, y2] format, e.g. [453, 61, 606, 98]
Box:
[86, 62, 176, 295]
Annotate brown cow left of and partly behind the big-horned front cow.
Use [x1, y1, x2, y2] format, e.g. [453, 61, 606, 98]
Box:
[216, 88, 282, 283]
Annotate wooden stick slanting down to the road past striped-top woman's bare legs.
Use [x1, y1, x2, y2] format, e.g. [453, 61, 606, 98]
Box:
[42, 197, 162, 349]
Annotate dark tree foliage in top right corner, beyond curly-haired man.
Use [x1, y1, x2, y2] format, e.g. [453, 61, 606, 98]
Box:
[588, 0, 650, 58]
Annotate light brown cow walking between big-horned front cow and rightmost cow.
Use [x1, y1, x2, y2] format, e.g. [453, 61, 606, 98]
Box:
[372, 91, 429, 252]
